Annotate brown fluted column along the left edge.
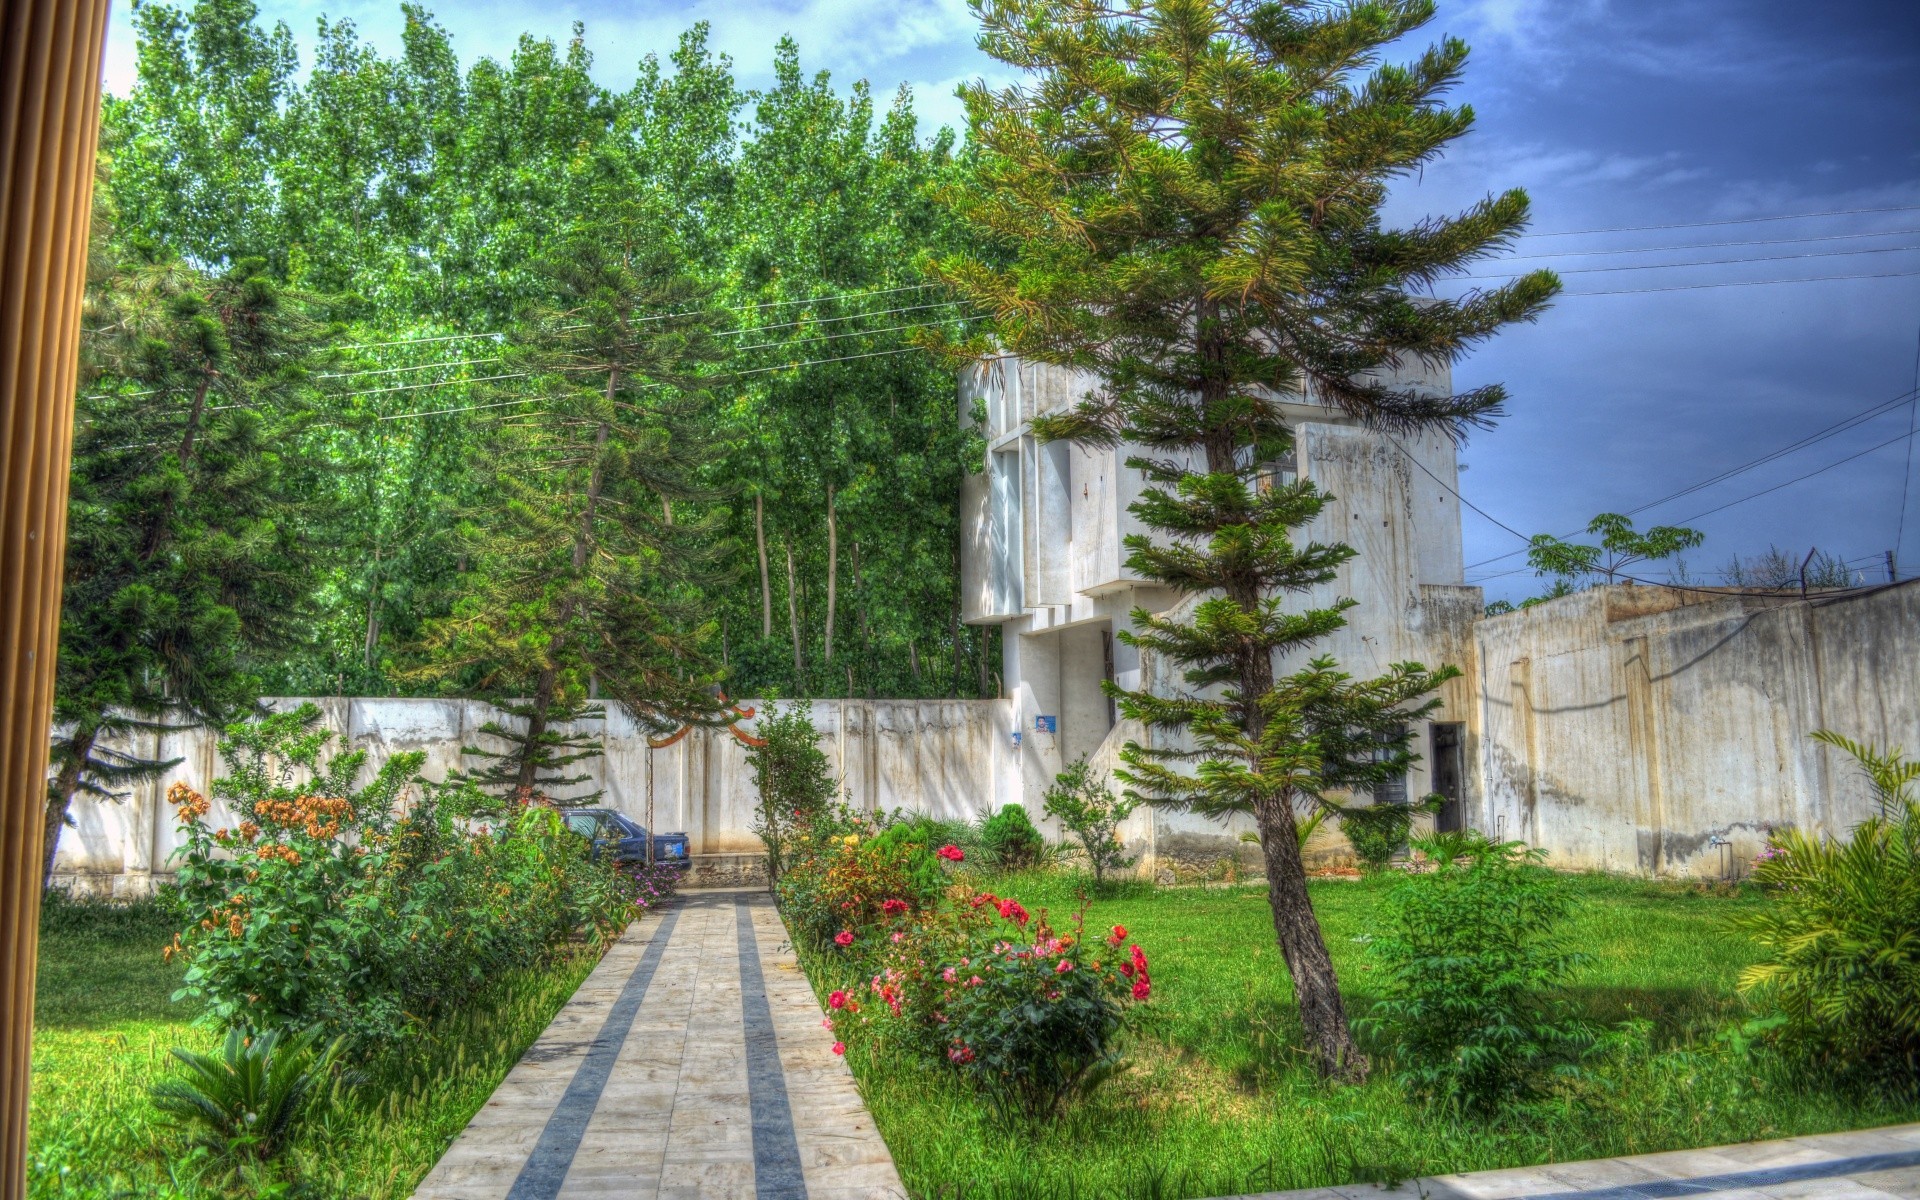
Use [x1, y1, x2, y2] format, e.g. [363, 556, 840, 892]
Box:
[0, 0, 108, 1200]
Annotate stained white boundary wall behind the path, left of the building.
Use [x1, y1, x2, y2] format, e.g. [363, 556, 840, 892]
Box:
[54, 699, 1021, 895]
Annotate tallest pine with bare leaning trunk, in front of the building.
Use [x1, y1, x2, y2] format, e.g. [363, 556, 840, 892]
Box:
[935, 0, 1557, 1077]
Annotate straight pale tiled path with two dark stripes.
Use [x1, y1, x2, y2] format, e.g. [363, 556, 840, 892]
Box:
[413, 889, 906, 1200]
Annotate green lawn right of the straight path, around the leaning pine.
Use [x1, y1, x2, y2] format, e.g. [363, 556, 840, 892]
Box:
[810, 874, 1920, 1200]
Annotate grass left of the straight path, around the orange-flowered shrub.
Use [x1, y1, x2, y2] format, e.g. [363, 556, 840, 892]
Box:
[29, 900, 614, 1200]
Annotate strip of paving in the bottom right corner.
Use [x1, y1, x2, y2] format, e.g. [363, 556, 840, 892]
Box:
[1238, 1125, 1920, 1200]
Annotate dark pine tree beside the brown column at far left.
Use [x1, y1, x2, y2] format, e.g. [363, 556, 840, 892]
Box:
[46, 219, 332, 890]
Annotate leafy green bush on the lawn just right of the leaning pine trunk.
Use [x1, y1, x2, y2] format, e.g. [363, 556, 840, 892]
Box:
[1361, 833, 1596, 1110]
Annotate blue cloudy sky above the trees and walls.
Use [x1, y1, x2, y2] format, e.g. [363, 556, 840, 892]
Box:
[106, 0, 1920, 597]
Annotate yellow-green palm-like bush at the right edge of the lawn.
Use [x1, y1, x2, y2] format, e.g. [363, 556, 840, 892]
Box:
[1740, 739, 1920, 1096]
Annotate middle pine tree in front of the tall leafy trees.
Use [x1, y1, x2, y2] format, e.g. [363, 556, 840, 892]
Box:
[415, 200, 726, 803]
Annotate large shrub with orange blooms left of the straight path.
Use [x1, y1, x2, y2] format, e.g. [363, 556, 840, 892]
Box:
[167, 705, 637, 1041]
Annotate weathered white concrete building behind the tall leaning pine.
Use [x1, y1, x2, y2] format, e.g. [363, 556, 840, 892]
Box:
[960, 359, 1480, 866]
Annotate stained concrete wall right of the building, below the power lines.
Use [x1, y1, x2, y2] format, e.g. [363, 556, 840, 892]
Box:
[1475, 584, 1920, 877]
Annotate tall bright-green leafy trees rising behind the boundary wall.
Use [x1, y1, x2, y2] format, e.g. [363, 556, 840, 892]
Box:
[100, 4, 998, 702]
